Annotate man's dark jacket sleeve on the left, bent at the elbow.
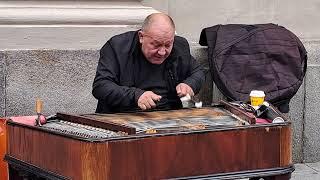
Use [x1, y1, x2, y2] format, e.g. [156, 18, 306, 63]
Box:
[92, 41, 144, 108]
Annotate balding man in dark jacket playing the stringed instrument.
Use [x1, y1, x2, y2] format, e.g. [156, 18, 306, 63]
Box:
[92, 13, 204, 113]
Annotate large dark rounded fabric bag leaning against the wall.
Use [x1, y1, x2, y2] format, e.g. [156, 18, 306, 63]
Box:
[199, 24, 307, 112]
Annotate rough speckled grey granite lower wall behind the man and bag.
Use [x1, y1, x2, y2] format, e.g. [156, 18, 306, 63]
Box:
[0, 42, 320, 162]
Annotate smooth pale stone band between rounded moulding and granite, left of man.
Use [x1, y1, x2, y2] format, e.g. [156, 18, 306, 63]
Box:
[0, 26, 139, 50]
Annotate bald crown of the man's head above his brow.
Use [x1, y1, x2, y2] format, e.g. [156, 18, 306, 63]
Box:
[141, 13, 175, 31]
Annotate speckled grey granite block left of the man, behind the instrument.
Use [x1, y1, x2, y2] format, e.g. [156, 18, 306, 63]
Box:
[6, 50, 98, 116]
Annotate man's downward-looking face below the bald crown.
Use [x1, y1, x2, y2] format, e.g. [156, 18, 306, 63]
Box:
[139, 29, 174, 64]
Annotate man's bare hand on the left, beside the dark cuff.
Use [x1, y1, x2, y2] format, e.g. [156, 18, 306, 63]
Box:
[138, 91, 161, 110]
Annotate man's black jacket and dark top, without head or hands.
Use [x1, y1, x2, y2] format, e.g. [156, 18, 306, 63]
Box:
[92, 31, 204, 113]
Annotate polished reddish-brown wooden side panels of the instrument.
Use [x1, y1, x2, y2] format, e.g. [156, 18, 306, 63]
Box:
[8, 119, 291, 180]
